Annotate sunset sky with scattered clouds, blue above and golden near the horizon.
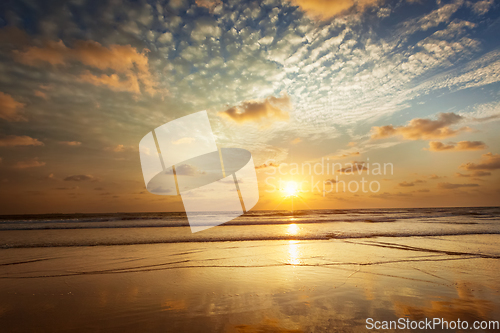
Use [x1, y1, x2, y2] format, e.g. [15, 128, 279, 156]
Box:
[0, 0, 500, 214]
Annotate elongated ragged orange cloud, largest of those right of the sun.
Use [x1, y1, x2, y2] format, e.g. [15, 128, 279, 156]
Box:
[372, 112, 470, 140]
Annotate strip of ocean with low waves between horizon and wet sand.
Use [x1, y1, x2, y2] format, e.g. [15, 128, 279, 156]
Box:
[0, 207, 500, 249]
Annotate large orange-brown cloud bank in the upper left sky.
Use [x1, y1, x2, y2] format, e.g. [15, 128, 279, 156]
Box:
[14, 40, 157, 96]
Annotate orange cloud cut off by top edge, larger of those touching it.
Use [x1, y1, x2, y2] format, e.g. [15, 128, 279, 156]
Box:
[292, 0, 379, 20]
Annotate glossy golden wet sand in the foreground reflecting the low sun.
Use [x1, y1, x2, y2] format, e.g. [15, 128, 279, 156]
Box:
[0, 235, 500, 332]
